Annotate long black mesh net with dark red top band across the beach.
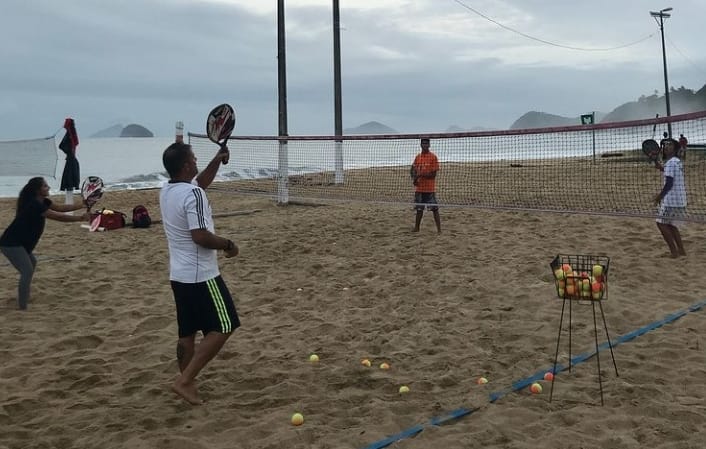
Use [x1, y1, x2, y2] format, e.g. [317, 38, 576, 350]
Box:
[189, 111, 706, 221]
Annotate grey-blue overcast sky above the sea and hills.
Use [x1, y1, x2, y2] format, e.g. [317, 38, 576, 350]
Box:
[0, 0, 706, 140]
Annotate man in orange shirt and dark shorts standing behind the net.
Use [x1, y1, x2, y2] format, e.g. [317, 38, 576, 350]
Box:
[411, 137, 441, 234]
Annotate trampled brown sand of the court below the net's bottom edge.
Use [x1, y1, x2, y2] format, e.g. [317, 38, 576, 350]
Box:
[0, 176, 706, 449]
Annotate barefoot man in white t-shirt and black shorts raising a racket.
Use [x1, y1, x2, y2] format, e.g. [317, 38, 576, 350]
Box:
[159, 142, 240, 405]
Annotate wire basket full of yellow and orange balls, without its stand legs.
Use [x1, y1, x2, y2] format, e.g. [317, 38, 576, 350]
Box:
[549, 254, 610, 301]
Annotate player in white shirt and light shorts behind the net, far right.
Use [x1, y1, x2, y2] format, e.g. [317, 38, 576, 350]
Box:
[655, 139, 686, 258]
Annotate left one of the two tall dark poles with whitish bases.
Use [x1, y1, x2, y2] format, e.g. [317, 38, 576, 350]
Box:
[277, 0, 289, 204]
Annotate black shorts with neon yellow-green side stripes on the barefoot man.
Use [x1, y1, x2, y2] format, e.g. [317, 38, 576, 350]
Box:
[171, 276, 240, 338]
